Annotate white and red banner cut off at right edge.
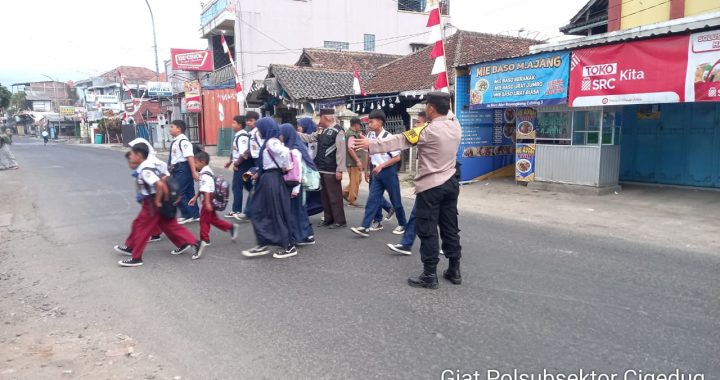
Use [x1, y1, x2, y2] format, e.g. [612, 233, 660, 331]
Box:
[685, 30, 720, 102]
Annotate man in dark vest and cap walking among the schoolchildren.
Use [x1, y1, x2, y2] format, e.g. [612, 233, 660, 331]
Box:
[300, 108, 347, 229]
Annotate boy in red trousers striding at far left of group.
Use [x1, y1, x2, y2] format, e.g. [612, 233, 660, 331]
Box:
[118, 144, 198, 267]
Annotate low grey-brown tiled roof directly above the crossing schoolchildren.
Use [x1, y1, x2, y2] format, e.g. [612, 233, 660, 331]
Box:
[269, 65, 371, 100]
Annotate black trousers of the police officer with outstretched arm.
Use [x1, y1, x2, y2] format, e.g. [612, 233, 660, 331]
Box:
[415, 177, 462, 270]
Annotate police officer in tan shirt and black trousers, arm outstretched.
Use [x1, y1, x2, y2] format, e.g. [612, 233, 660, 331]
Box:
[354, 92, 462, 289]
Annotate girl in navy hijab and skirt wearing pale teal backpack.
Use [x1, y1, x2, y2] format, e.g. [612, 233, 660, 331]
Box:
[280, 124, 317, 254]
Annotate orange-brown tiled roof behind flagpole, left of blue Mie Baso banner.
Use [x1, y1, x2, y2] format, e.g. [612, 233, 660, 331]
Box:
[366, 31, 539, 94]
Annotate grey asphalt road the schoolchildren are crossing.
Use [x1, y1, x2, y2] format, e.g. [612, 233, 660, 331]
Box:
[0, 139, 720, 379]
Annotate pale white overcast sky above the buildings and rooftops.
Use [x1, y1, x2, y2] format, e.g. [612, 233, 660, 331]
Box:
[0, 0, 587, 87]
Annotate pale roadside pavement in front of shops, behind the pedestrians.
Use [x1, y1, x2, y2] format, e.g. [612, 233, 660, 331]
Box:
[76, 144, 720, 254]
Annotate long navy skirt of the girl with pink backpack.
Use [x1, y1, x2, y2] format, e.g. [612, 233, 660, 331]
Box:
[250, 170, 290, 248]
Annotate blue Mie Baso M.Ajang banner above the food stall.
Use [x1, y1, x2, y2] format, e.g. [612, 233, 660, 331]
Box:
[470, 52, 570, 109]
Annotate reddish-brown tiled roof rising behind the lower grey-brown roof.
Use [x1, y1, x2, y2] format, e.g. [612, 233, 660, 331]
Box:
[295, 49, 402, 71]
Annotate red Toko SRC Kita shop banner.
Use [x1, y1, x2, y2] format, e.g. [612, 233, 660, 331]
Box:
[570, 35, 689, 107]
